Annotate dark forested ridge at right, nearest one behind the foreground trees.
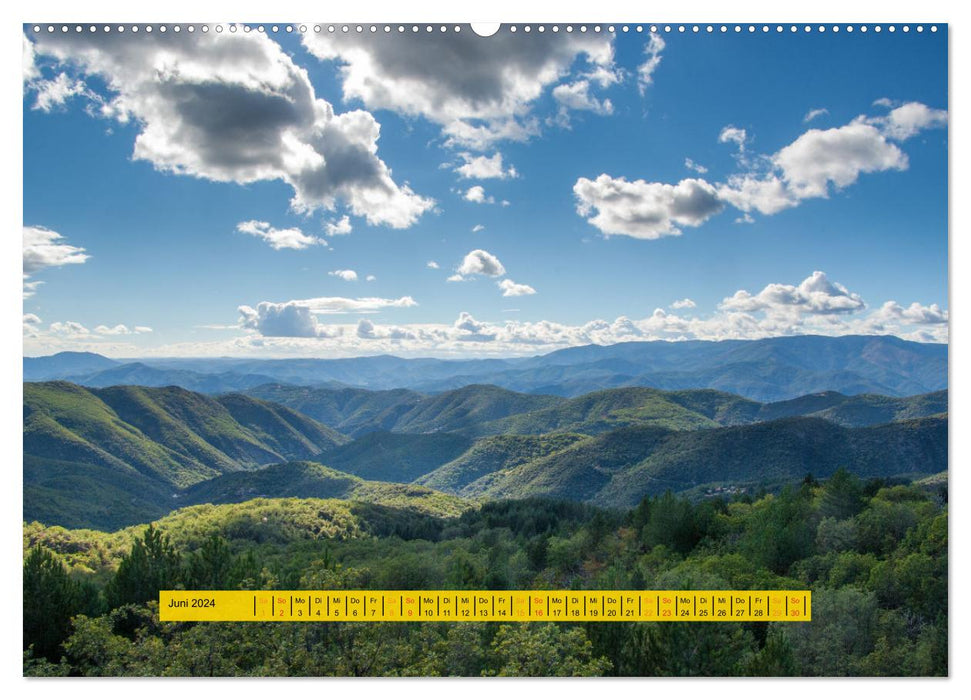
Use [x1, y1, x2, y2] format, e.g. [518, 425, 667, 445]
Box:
[470, 418, 947, 506]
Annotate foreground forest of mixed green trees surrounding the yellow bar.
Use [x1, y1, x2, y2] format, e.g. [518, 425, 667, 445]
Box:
[24, 471, 947, 676]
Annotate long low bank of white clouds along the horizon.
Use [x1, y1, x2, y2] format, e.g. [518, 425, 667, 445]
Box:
[36, 272, 948, 357]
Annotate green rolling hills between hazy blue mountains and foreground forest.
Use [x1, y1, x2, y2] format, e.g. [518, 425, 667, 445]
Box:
[24, 381, 947, 527]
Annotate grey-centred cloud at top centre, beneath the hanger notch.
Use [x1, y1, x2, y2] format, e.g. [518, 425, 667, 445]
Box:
[302, 31, 613, 150]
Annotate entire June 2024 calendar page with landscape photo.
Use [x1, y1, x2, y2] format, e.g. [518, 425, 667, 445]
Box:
[21, 21, 950, 678]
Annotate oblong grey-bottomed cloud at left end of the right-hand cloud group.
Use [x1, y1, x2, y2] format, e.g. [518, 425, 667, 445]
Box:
[573, 174, 723, 239]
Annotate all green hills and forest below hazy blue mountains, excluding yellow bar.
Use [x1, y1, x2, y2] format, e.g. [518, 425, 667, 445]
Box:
[23, 380, 948, 676]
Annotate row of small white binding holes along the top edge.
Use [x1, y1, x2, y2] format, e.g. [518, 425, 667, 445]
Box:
[33, 24, 937, 34]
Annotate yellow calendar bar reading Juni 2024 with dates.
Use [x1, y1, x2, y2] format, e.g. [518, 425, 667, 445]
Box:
[159, 591, 812, 622]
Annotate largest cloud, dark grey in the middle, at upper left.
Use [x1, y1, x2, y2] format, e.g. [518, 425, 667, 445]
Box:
[25, 32, 434, 228]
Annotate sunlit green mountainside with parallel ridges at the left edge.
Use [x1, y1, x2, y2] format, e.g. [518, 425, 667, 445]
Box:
[23, 382, 347, 526]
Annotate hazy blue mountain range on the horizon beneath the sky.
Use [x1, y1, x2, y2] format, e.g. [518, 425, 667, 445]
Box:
[24, 336, 948, 401]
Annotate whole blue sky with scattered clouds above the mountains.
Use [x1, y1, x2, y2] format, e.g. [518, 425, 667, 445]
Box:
[23, 26, 948, 357]
